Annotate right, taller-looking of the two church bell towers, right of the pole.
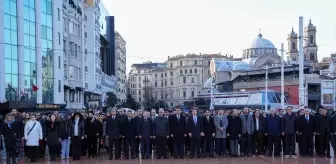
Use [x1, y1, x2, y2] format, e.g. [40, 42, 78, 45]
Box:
[303, 19, 318, 63]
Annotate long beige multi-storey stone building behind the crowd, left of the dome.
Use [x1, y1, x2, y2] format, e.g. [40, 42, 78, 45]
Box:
[129, 54, 228, 107]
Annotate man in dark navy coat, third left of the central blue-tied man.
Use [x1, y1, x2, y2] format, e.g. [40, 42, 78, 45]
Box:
[138, 111, 153, 159]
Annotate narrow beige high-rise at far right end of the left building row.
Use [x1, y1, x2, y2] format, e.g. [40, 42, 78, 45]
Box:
[115, 32, 127, 104]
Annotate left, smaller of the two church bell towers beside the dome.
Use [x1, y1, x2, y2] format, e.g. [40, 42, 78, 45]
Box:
[287, 27, 299, 63]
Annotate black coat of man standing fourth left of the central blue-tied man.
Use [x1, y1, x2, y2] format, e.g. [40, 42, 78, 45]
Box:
[122, 118, 138, 139]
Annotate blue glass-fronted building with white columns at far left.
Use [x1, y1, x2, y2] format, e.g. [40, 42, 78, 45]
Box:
[0, 0, 63, 104]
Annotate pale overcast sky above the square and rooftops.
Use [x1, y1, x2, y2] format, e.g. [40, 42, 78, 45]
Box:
[102, 0, 336, 71]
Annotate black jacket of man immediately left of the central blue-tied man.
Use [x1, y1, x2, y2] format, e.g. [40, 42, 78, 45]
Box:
[169, 115, 187, 139]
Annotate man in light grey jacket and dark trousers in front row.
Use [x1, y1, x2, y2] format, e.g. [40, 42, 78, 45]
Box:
[214, 109, 228, 156]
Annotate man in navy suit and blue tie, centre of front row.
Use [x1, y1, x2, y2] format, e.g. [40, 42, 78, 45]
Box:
[187, 108, 204, 158]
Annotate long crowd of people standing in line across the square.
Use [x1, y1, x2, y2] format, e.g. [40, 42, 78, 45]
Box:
[0, 107, 336, 163]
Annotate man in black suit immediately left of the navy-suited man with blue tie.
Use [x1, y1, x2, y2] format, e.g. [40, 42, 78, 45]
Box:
[169, 108, 187, 159]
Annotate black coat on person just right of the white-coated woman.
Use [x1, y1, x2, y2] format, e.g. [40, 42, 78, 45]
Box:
[46, 121, 61, 145]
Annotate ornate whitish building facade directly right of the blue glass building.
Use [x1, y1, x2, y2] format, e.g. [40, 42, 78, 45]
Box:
[61, 0, 88, 109]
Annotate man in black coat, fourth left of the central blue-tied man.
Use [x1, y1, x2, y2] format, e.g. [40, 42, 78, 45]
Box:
[122, 110, 137, 159]
